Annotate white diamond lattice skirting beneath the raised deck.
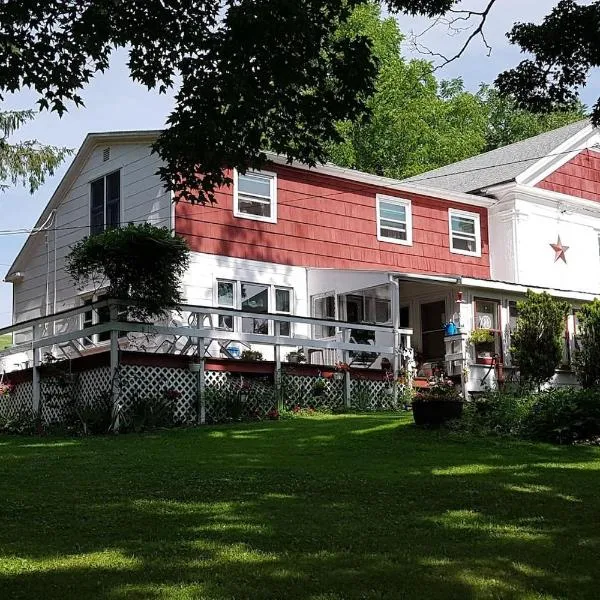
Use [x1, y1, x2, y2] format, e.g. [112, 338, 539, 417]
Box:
[0, 365, 399, 424]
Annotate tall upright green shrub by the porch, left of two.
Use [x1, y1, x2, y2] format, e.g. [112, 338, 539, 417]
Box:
[511, 290, 569, 388]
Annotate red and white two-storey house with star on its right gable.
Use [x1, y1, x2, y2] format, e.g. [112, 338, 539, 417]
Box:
[4, 121, 600, 390]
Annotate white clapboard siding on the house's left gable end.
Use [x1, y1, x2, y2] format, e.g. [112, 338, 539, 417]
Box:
[13, 143, 171, 322]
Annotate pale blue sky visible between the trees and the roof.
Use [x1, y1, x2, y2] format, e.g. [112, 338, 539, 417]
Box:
[0, 0, 600, 325]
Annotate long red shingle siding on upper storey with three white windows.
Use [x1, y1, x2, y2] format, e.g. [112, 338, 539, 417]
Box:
[175, 165, 490, 278]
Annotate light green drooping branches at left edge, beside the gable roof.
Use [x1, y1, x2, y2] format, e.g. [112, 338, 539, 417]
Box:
[0, 110, 71, 193]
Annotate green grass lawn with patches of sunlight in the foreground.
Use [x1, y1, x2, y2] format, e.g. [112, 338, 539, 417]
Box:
[0, 415, 600, 600]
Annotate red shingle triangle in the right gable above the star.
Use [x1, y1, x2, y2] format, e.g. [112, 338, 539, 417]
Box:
[537, 150, 600, 202]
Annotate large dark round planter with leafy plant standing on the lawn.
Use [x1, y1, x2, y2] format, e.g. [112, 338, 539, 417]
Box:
[412, 380, 463, 426]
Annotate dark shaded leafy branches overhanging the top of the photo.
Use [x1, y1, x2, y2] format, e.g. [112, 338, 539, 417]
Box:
[0, 0, 600, 202]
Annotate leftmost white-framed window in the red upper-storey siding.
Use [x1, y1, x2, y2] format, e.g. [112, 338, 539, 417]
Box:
[233, 170, 277, 223]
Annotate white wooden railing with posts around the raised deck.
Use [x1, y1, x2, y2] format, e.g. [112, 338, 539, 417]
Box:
[0, 300, 413, 421]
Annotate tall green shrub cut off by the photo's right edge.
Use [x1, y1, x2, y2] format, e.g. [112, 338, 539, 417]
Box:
[573, 298, 600, 388]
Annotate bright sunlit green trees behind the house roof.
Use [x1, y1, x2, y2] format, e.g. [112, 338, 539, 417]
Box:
[330, 3, 584, 179]
